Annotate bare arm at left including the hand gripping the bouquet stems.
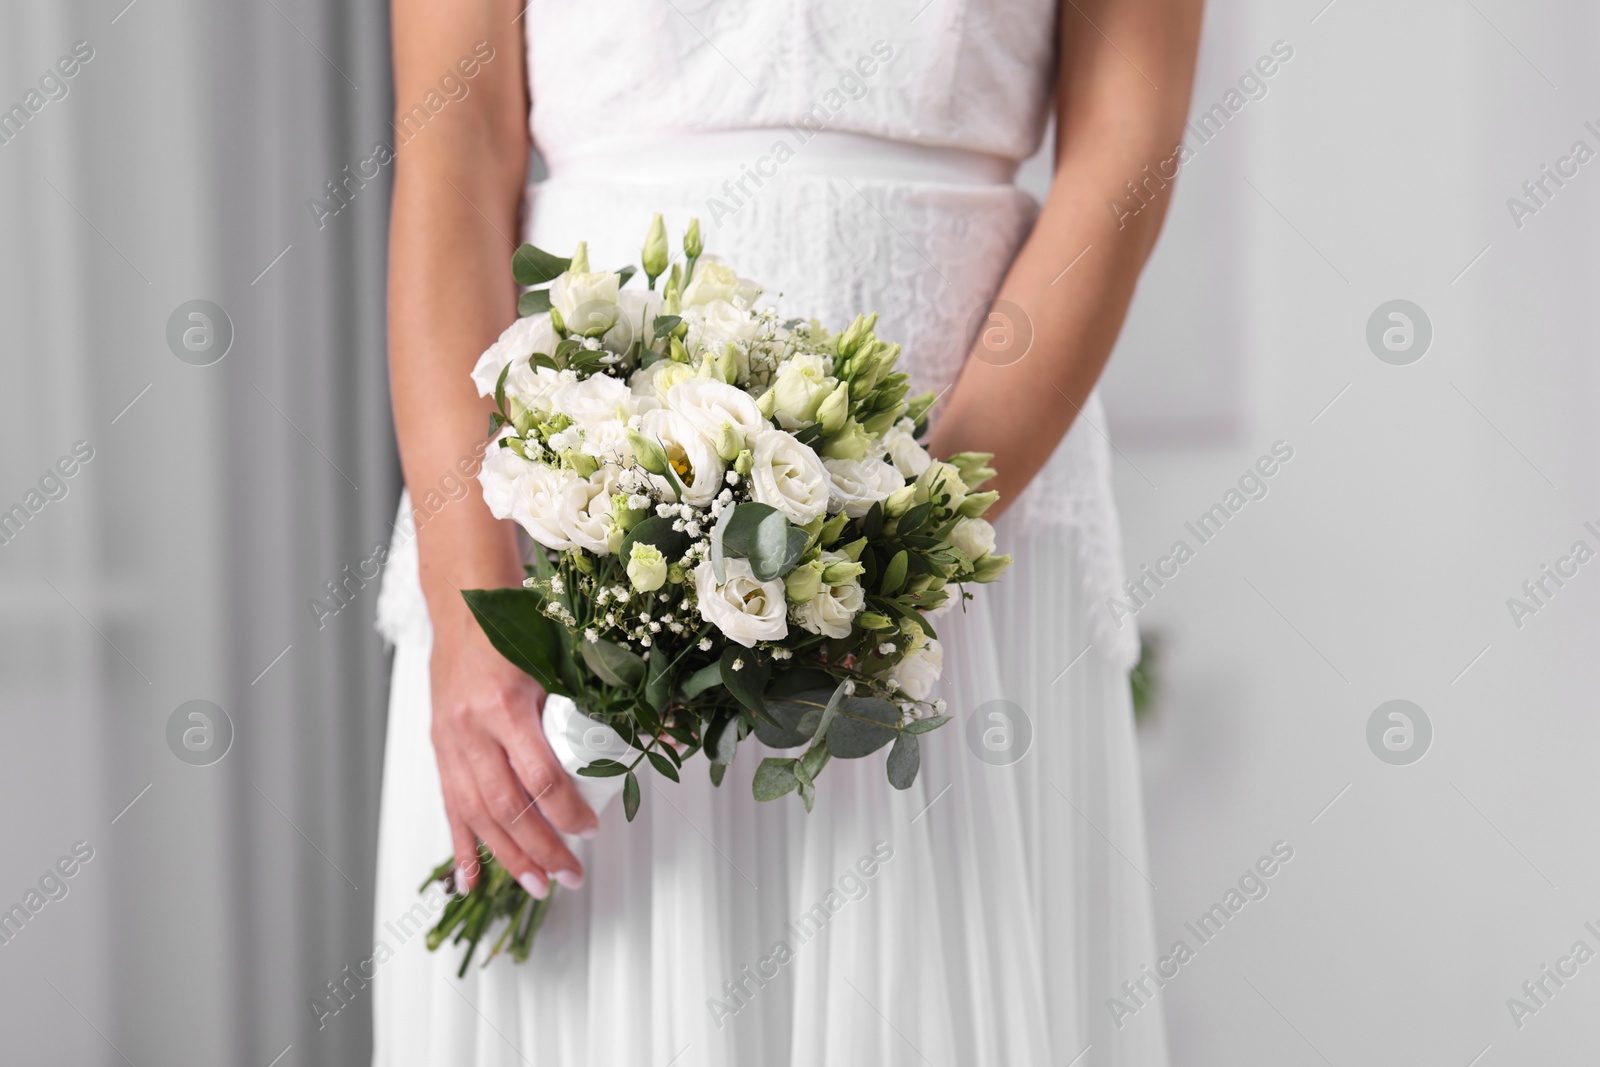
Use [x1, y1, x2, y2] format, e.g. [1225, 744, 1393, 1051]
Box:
[389, 0, 595, 896]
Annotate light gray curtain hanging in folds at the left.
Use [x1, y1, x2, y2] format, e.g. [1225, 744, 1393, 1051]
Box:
[0, 0, 398, 1067]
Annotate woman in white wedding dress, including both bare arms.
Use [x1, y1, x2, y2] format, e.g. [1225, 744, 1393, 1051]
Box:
[374, 0, 1200, 1067]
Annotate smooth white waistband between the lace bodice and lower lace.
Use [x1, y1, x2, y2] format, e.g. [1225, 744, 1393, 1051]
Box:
[542, 125, 1018, 186]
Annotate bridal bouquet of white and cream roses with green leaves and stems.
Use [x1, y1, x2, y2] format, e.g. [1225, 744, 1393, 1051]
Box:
[424, 214, 1011, 973]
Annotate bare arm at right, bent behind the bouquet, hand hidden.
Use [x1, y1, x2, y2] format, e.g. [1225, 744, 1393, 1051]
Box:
[930, 0, 1202, 517]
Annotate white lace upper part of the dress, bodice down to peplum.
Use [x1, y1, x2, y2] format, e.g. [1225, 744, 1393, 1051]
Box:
[480, 0, 1134, 661]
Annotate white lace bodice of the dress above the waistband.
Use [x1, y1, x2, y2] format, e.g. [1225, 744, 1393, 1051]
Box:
[525, 0, 1058, 163]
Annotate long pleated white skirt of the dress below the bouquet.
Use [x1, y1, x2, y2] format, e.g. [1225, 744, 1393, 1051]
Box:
[373, 520, 1166, 1067]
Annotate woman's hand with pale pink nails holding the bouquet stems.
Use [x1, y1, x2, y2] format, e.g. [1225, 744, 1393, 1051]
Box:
[432, 606, 598, 899]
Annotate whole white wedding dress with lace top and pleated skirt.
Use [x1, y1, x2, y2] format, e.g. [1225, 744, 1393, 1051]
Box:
[373, 0, 1166, 1067]
